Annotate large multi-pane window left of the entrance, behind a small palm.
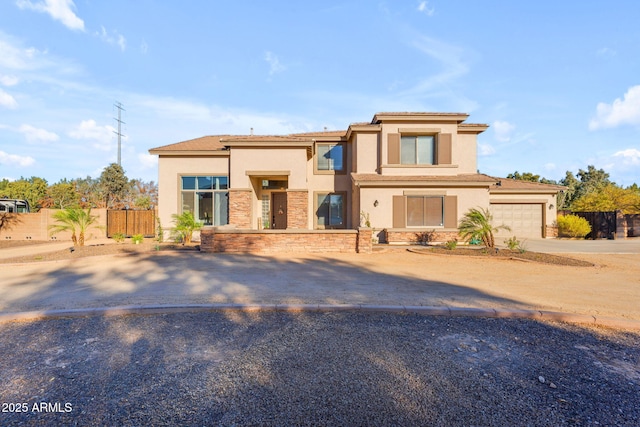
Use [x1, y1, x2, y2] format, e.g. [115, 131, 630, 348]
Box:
[181, 176, 229, 225]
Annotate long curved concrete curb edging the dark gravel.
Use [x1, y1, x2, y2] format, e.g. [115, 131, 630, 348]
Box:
[0, 304, 640, 330]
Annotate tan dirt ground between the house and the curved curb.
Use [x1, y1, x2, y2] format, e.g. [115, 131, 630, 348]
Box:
[0, 242, 640, 321]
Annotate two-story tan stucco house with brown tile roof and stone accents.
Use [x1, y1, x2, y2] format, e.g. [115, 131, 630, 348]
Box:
[149, 113, 562, 251]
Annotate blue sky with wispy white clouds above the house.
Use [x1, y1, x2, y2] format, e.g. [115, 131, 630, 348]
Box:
[0, 0, 640, 185]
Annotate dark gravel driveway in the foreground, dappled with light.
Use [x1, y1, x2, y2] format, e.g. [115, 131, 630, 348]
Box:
[0, 312, 640, 426]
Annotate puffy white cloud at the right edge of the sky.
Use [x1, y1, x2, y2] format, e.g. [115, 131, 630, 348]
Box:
[589, 85, 640, 130]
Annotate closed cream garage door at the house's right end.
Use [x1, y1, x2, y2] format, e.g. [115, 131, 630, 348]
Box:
[491, 203, 542, 238]
